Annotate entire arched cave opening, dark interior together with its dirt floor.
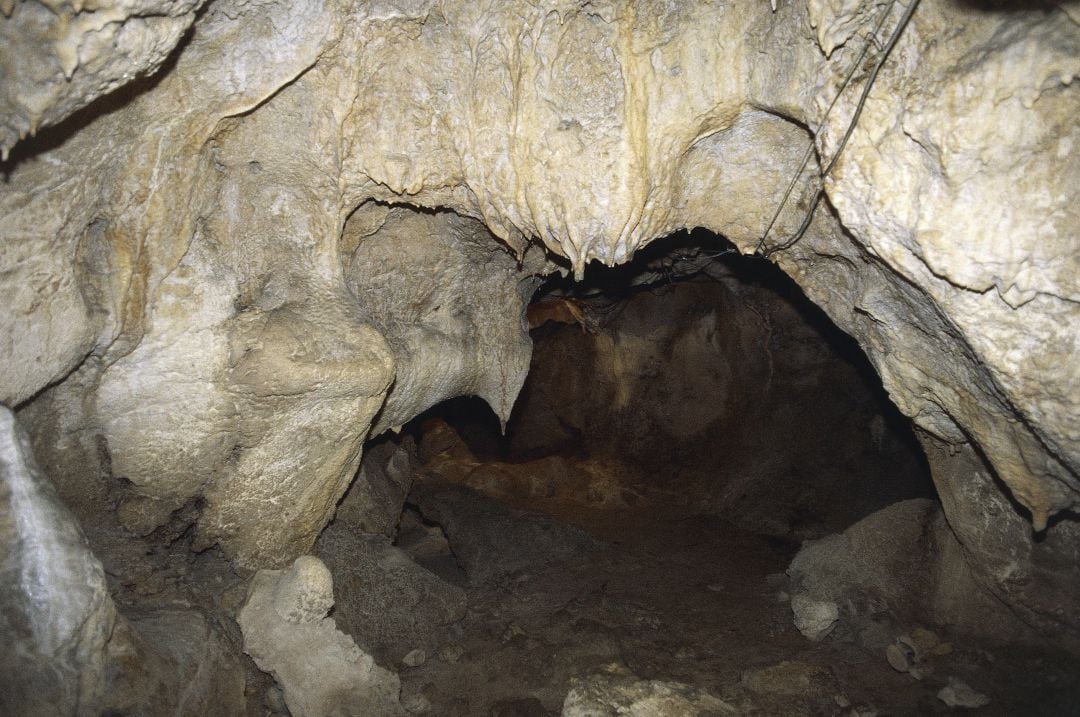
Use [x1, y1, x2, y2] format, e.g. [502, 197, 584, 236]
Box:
[319, 230, 980, 715]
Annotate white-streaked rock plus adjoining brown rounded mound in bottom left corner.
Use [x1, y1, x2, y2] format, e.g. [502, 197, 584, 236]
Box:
[0, 406, 244, 717]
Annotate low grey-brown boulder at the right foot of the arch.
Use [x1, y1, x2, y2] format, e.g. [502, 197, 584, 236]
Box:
[787, 499, 1045, 651]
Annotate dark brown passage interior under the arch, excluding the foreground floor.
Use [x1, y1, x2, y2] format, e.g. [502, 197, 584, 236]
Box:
[411, 230, 934, 544]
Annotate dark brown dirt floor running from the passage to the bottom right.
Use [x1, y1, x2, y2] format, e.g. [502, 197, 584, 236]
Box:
[395, 460, 1080, 717]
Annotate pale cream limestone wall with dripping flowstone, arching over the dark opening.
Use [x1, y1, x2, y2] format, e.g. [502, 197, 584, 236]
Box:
[0, 0, 1080, 630]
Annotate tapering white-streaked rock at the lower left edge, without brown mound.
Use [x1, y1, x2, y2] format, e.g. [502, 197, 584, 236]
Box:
[0, 406, 118, 715]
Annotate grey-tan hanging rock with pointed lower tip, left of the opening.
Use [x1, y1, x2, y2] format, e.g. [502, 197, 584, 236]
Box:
[341, 205, 543, 434]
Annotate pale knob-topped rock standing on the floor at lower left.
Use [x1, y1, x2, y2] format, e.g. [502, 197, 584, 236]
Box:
[238, 556, 405, 717]
